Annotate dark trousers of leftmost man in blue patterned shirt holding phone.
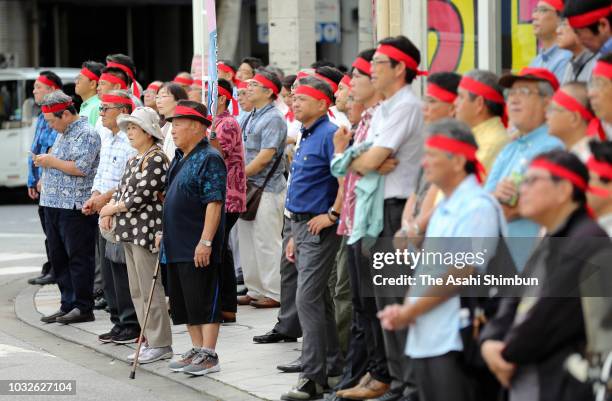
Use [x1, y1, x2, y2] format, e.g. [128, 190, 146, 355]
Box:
[45, 207, 98, 312]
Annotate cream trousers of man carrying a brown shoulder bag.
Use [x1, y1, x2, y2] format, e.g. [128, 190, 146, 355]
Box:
[237, 191, 286, 302]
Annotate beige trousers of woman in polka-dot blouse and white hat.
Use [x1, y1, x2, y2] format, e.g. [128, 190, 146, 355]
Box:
[123, 242, 172, 348]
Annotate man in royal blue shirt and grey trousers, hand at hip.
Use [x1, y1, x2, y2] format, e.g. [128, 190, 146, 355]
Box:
[282, 77, 342, 400]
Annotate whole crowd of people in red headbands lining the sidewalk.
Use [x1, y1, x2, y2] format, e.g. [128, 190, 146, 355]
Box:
[23, 0, 612, 401]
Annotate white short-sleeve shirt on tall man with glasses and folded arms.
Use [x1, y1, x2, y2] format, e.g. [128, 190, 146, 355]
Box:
[368, 85, 424, 199]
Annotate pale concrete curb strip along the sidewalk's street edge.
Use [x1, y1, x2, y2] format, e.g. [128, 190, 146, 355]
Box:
[15, 286, 265, 401]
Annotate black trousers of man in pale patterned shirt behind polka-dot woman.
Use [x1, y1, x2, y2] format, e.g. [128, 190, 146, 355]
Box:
[98, 235, 140, 330]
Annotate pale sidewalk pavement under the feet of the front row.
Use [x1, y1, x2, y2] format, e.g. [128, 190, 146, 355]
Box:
[15, 285, 301, 401]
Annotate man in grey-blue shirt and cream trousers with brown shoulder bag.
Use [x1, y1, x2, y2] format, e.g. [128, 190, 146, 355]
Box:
[237, 70, 287, 308]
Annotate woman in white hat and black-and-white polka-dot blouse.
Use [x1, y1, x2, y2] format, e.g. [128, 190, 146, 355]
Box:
[100, 107, 173, 364]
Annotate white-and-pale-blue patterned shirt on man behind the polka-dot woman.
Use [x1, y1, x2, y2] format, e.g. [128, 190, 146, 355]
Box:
[91, 130, 136, 194]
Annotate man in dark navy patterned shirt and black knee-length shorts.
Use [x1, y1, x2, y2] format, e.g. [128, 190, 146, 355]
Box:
[162, 100, 227, 376]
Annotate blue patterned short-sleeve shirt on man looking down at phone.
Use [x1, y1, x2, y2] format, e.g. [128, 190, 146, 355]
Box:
[40, 117, 101, 209]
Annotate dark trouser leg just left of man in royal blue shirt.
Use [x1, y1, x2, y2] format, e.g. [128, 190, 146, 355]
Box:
[274, 217, 302, 338]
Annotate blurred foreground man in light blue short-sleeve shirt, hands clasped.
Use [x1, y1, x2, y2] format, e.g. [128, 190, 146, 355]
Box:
[379, 119, 505, 401]
